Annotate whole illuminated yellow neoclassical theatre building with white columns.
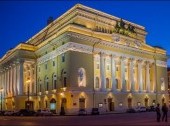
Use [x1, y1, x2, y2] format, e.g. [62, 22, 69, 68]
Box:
[0, 4, 168, 113]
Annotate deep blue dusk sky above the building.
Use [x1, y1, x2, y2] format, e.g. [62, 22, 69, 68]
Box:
[0, 0, 170, 66]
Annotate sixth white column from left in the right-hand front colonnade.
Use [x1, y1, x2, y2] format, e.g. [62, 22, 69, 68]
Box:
[146, 61, 150, 92]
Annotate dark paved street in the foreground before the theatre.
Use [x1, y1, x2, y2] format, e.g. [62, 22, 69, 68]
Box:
[0, 112, 170, 126]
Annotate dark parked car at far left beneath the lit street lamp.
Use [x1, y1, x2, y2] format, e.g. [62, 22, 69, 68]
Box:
[14, 109, 35, 116]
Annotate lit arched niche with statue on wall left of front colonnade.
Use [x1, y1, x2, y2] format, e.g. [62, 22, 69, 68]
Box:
[78, 68, 86, 87]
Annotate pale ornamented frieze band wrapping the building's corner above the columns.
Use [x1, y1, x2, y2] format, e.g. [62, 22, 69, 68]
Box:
[37, 42, 154, 64]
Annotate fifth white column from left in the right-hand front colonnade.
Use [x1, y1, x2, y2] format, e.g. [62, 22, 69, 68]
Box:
[138, 59, 143, 92]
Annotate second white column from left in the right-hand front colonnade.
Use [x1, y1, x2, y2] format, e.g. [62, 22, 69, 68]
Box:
[111, 55, 117, 92]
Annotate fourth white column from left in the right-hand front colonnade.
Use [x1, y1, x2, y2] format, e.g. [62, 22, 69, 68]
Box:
[129, 58, 135, 92]
